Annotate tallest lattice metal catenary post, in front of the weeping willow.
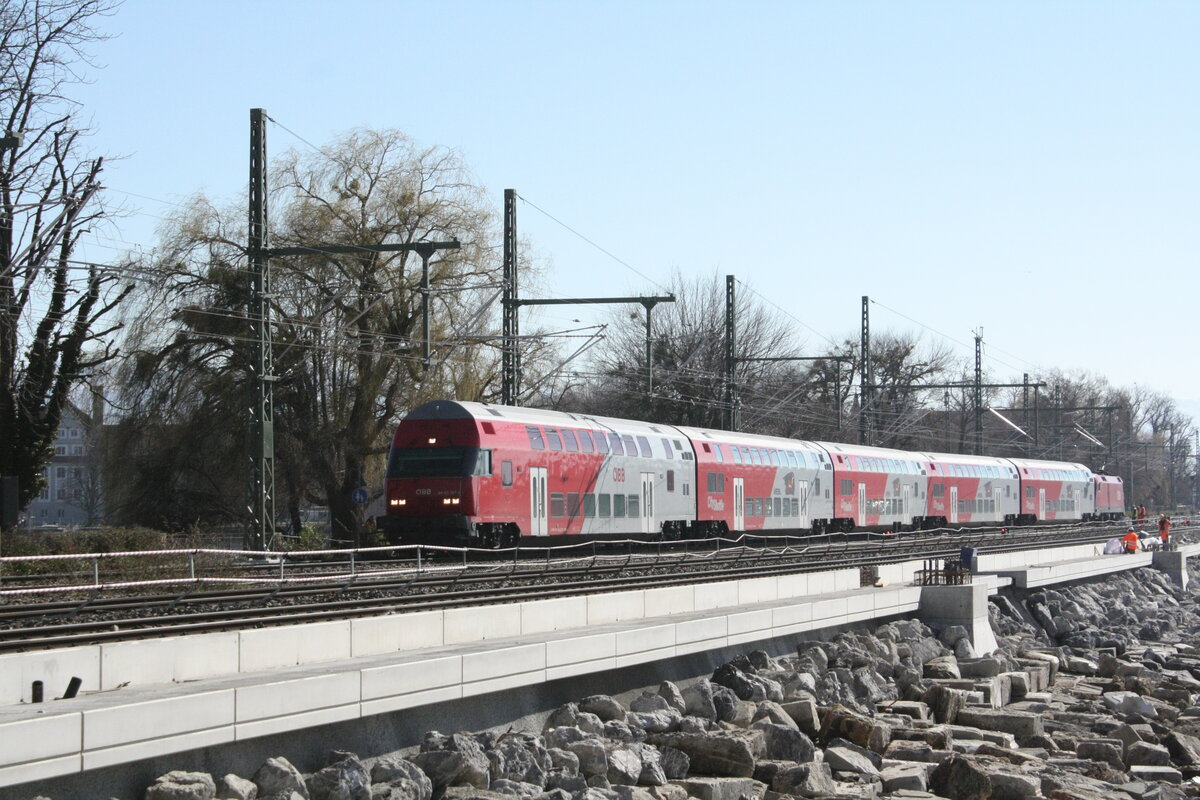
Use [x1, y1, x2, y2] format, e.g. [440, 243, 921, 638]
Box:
[246, 108, 275, 549]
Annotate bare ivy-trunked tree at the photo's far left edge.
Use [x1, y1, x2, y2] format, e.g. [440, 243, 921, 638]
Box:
[0, 0, 127, 507]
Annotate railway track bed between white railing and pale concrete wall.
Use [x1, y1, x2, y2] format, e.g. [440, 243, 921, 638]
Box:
[0, 525, 1161, 652]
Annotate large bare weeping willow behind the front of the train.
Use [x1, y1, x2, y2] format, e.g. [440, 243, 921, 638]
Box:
[114, 131, 499, 540]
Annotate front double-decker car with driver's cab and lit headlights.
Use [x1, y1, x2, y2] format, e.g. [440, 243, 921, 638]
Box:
[382, 401, 696, 546]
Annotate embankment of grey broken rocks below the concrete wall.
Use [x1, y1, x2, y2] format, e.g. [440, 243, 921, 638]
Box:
[98, 569, 1200, 800]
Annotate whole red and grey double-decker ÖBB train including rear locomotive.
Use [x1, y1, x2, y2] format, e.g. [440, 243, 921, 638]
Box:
[379, 401, 1124, 546]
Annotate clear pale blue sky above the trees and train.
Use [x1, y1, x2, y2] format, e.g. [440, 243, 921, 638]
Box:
[77, 0, 1200, 414]
